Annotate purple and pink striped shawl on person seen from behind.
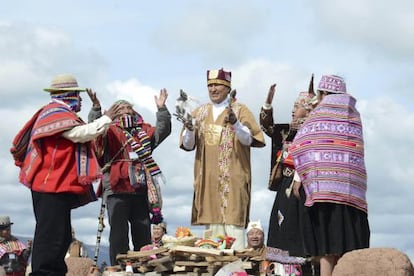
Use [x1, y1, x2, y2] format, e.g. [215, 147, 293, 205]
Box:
[289, 94, 367, 212]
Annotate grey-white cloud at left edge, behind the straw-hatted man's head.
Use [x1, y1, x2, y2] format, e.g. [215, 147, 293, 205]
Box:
[0, 22, 105, 108]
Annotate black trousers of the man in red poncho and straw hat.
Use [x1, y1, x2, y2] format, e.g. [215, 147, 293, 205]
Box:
[30, 191, 76, 276]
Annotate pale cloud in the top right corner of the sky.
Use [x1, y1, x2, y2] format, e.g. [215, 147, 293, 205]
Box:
[314, 0, 414, 58]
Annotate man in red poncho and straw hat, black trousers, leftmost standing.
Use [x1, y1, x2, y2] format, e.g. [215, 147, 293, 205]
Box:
[10, 74, 117, 276]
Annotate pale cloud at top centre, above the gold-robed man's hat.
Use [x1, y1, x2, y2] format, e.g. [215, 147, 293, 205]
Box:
[151, 1, 268, 63]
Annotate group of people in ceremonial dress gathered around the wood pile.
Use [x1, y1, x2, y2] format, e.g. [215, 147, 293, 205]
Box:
[5, 69, 370, 276]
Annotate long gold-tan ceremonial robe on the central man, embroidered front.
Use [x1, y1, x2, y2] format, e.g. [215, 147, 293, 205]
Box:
[181, 102, 265, 227]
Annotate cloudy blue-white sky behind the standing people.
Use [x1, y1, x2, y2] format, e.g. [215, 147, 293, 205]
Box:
[0, 0, 414, 260]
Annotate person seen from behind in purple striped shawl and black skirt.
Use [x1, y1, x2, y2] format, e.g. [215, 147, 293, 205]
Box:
[292, 75, 370, 275]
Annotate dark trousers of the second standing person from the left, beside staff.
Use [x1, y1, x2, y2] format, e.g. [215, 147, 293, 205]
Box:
[106, 194, 151, 265]
